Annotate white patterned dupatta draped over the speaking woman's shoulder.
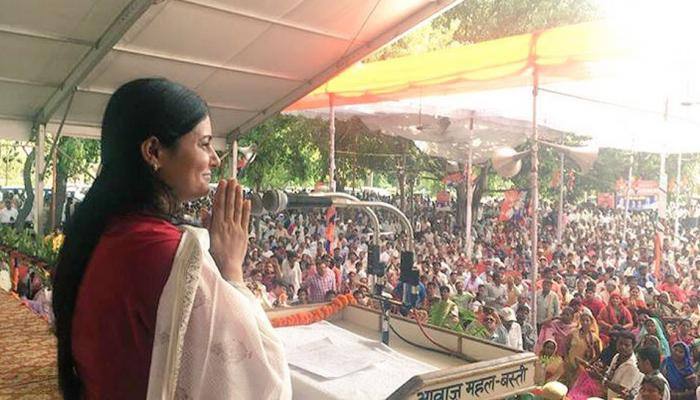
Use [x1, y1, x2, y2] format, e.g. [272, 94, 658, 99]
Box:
[147, 226, 292, 400]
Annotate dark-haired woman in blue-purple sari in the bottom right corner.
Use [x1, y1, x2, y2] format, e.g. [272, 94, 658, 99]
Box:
[661, 342, 697, 400]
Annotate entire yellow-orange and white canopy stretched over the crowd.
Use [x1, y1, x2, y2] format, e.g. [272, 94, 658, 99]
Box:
[288, 15, 700, 155]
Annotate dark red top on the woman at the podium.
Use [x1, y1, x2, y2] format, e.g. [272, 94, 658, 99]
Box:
[72, 214, 182, 399]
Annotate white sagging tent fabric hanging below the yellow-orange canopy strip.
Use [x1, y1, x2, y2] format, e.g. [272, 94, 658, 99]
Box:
[296, 58, 700, 163]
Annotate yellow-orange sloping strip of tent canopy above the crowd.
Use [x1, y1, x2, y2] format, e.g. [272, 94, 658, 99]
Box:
[288, 22, 632, 110]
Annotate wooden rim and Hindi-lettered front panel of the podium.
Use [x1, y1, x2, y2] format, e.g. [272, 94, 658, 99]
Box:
[268, 304, 537, 400]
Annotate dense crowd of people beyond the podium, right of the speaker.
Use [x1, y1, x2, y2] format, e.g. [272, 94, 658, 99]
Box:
[205, 190, 700, 399]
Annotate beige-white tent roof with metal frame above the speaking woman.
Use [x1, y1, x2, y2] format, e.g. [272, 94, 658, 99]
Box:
[0, 0, 459, 144]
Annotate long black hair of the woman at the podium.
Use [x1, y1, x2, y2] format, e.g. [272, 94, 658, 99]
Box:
[53, 78, 209, 399]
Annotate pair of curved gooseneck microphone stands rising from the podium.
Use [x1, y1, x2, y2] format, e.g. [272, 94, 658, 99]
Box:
[309, 192, 418, 346]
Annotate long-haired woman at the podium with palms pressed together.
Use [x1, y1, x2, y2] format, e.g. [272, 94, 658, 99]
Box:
[53, 79, 291, 399]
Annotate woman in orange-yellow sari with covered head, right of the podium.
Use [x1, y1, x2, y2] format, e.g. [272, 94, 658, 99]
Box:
[565, 309, 604, 400]
